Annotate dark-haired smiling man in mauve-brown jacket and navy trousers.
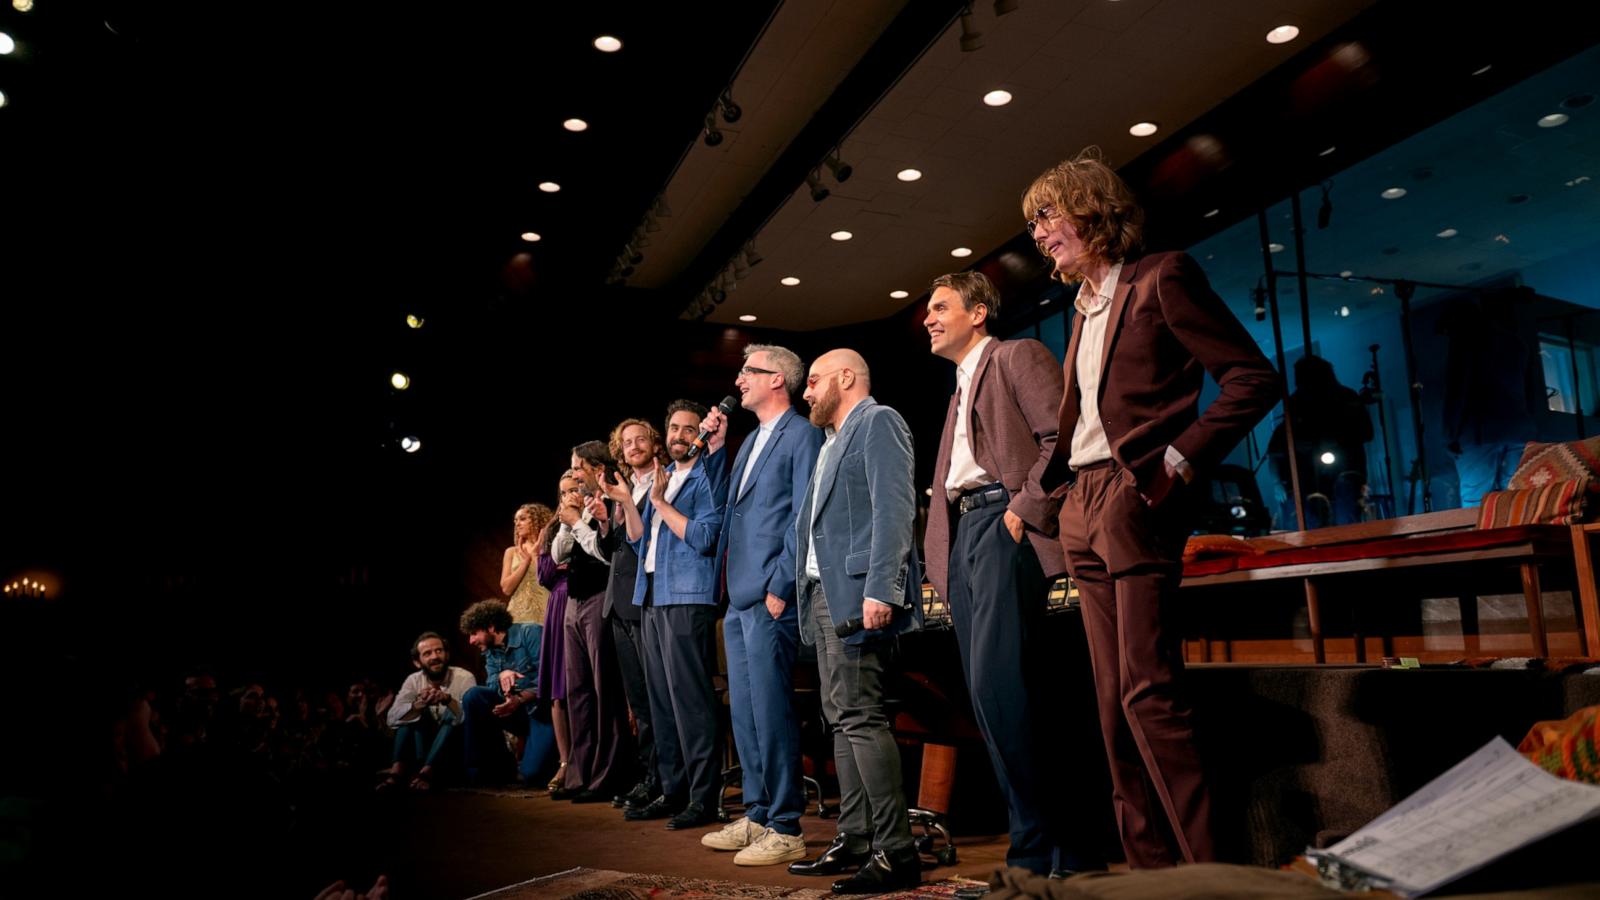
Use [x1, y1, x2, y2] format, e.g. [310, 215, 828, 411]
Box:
[923, 272, 1106, 874]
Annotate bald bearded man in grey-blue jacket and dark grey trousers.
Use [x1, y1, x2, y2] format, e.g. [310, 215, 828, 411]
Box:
[789, 349, 922, 894]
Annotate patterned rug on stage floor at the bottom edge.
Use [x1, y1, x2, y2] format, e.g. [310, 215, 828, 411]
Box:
[470, 868, 982, 900]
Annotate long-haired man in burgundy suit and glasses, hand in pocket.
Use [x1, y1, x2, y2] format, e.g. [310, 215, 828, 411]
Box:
[1022, 152, 1278, 868]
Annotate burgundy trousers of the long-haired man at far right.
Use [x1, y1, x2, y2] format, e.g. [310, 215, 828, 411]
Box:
[1061, 464, 1214, 868]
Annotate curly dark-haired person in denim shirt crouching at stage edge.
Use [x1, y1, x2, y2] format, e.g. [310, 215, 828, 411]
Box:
[461, 601, 555, 783]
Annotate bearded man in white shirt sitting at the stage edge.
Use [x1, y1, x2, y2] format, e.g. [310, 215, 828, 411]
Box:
[378, 631, 478, 791]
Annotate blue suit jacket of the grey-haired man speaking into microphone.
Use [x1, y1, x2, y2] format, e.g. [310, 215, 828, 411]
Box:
[707, 408, 822, 610]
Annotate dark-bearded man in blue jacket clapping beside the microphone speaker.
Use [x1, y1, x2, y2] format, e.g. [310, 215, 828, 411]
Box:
[606, 400, 726, 830]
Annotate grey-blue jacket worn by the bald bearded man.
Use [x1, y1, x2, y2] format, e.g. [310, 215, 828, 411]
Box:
[795, 397, 922, 644]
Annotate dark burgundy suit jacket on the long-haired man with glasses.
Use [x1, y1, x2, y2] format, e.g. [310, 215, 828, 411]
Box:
[1040, 253, 1280, 493]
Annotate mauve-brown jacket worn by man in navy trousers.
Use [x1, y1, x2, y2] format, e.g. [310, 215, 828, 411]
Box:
[923, 338, 1067, 597]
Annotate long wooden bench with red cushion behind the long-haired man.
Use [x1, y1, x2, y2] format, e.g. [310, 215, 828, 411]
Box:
[1184, 509, 1600, 663]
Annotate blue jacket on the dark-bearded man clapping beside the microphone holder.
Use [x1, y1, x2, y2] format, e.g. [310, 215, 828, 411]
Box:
[632, 456, 728, 607]
